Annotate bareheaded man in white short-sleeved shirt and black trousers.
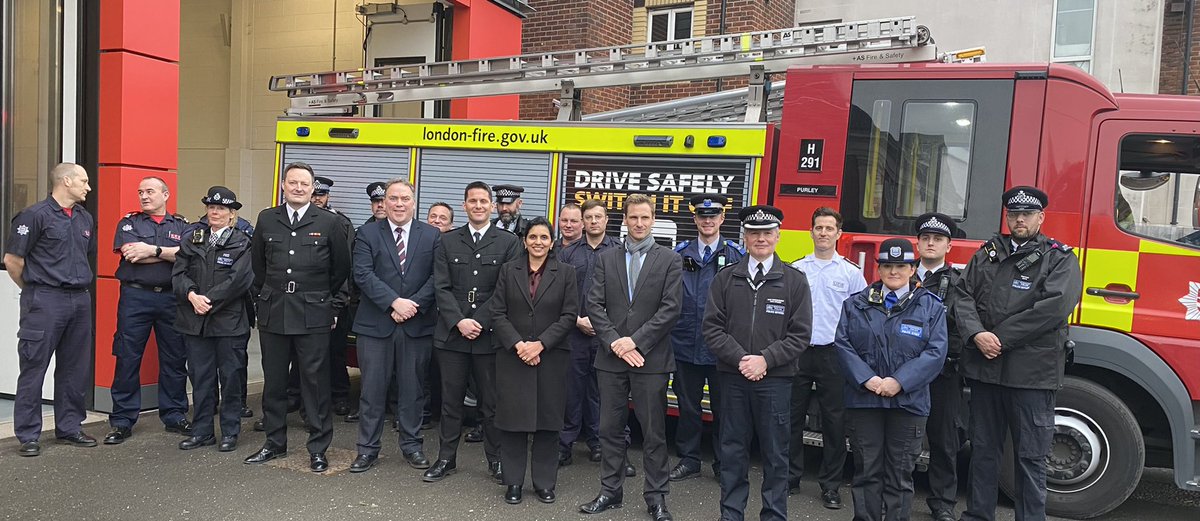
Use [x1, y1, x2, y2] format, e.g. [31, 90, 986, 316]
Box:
[787, 206, 866, 509]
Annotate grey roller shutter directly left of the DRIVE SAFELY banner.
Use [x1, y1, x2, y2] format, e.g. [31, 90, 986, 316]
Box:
[415, 149, 550, 227]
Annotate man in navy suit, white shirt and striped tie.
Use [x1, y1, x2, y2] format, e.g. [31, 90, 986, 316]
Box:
[350, 179, 442, 472]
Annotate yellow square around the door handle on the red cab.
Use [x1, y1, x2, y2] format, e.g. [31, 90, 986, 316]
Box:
[1079, 248, 1139, 331]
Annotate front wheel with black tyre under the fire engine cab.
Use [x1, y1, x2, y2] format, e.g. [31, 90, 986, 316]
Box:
[1000, 376, 1146, 519]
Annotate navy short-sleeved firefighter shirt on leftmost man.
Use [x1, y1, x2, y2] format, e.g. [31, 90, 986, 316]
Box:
[5, 197, 96, 289]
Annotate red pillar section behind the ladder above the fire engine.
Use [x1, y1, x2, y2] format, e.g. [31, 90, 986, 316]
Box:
[450, 0, 522, 119]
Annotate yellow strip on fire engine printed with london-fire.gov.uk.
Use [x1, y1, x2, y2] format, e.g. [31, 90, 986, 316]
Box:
[275, 119, 767, 157]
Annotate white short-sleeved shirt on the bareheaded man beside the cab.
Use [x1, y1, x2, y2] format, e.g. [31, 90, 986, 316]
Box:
[792, 253, 866, 346]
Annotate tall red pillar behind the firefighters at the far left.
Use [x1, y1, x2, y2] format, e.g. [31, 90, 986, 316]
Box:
[92, 0, 179, 412]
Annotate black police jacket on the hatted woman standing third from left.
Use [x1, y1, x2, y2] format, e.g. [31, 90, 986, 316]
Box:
[172, 228, 254, 336]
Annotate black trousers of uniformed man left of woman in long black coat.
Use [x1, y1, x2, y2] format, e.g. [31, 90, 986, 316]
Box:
[436, 349, 500, 463]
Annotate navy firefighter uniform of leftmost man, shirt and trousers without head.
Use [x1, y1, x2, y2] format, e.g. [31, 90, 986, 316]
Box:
[5, 197, 96, 448]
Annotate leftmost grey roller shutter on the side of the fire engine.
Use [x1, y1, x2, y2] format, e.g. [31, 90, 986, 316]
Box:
[280, 144, 412, 226]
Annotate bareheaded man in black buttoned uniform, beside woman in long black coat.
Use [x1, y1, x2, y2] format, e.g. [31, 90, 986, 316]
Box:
[422, 181, 521, 483]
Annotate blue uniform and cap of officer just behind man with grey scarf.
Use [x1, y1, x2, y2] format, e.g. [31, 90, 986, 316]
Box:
[671, 194, 745, 481]
